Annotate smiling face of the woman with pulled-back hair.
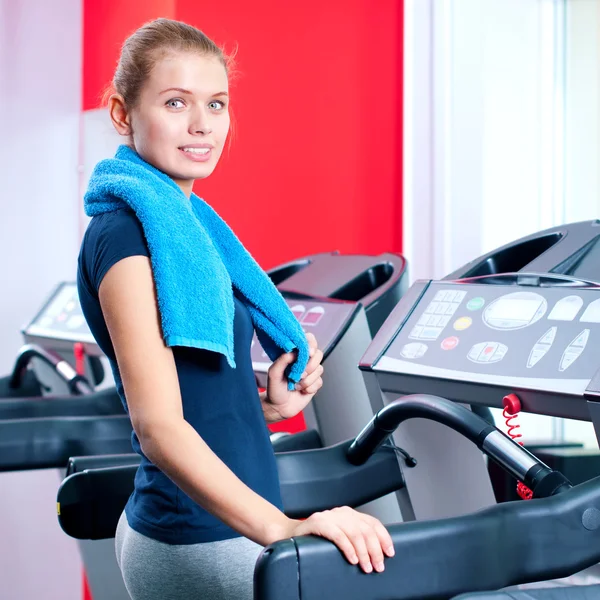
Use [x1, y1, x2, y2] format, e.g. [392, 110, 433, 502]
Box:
[129, 52, 230, 196]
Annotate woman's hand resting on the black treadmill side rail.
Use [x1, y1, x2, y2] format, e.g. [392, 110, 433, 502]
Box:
[282, 506, 394, 573]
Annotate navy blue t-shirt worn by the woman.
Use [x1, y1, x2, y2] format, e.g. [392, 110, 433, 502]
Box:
[77, 209, 282, 544]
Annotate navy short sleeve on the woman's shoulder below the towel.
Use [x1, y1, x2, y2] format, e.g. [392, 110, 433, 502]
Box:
[80, 209, 150, 294]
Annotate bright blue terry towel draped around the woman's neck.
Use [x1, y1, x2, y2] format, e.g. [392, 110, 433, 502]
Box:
[84, 146, 309, 390]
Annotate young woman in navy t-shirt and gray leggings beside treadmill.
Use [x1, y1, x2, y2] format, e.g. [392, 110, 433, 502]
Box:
[78, 19, 393, 600]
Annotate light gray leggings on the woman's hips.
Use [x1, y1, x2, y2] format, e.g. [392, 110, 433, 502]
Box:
[115, 513, 262, 600]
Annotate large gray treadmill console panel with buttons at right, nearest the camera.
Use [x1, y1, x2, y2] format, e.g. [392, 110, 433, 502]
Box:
[370, 281, 600, 391]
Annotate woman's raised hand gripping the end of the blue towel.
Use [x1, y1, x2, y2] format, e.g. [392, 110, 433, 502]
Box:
[263, 333, 323, 423]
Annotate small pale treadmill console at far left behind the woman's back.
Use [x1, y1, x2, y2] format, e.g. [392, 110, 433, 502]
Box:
[23, 282, 96, 345]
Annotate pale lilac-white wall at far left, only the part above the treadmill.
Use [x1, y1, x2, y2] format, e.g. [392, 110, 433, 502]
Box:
[0, 0, 82, 374]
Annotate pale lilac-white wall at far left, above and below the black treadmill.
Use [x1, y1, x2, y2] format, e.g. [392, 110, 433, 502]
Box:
[0, 0, 82, 600]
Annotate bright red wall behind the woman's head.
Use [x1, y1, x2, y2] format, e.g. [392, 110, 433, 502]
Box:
[83, 0, 403, 268]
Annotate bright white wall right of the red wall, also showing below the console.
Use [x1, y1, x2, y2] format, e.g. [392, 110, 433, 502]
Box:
[403, 0, 600, 446]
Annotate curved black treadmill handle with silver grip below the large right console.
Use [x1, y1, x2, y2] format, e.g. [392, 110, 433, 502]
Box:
[347, 394, 573, 498]
